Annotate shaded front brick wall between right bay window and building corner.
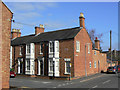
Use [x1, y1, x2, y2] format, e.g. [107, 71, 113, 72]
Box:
[59, 39, 74, 77]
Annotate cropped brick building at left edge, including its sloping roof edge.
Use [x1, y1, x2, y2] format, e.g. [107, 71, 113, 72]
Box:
[0, 0, 13, 90]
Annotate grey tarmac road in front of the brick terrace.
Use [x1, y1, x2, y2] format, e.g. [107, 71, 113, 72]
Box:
[10, 73, 120, 90]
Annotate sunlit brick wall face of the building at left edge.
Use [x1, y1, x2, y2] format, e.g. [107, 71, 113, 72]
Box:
[0, 3, 12, 88]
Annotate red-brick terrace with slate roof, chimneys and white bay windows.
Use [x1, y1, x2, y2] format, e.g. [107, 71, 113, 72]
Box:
[11, 13, 107, 78]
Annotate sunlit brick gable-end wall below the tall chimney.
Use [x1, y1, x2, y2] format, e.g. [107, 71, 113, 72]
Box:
[74, 28, 93, 77]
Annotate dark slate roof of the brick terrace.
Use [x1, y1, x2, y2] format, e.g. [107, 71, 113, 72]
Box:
[11, 27, 81, 45]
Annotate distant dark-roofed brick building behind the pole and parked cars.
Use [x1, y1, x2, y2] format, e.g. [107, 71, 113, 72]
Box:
[103, 49, 120, 66]
